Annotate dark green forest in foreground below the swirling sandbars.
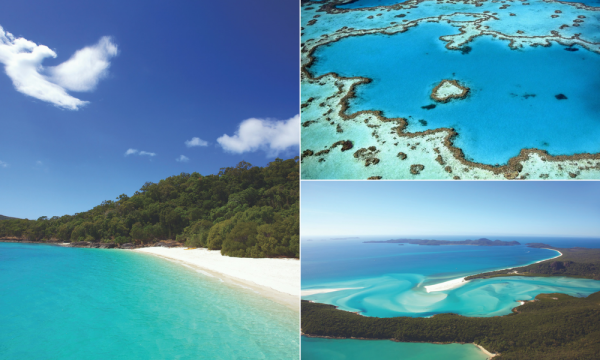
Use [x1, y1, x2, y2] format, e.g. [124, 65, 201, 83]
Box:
[302, 292, 600, 360]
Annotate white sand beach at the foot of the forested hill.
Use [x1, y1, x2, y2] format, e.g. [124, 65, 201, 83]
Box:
[133, 247, 300, 311]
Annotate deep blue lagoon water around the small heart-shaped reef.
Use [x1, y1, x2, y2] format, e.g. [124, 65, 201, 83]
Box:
[310, 24, 600, 164]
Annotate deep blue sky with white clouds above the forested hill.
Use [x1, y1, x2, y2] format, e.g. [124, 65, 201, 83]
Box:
[0, 0, 299, 219]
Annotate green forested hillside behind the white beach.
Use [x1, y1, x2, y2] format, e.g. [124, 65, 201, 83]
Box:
[0, 157, 300, 258]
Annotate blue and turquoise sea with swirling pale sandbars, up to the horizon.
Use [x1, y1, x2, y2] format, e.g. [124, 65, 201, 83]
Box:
[302, 237, 600, 317]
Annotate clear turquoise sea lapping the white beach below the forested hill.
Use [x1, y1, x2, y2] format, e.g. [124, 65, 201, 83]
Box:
[0, 243, 299, 359]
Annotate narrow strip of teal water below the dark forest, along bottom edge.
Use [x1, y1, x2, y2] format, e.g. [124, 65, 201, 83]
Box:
[302, 336, 487, 360]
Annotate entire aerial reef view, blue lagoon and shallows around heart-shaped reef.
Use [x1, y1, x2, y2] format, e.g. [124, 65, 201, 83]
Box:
[301, 0, 600, 179]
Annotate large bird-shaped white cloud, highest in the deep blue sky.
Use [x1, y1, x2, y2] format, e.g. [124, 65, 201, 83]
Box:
[0, 26, 117, 110]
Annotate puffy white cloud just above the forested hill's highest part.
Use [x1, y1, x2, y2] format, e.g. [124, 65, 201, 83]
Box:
[217, 115, 300, 156]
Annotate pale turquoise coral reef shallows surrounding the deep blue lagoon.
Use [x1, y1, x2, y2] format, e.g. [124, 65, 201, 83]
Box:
[301, 0, 600, 180]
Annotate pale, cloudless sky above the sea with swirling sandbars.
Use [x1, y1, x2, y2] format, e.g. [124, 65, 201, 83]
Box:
[300, 181, 600, 238]
